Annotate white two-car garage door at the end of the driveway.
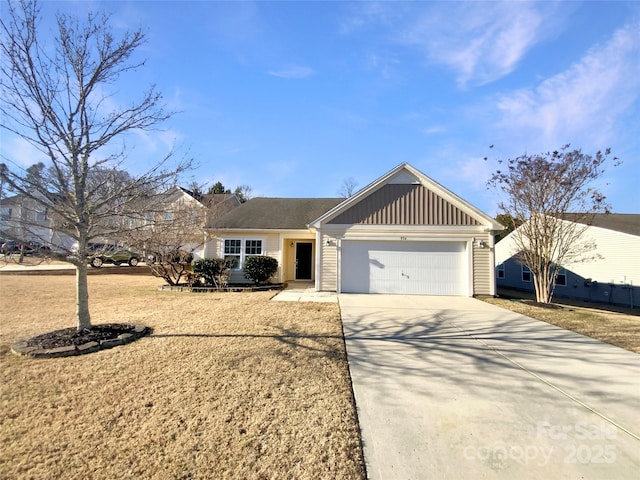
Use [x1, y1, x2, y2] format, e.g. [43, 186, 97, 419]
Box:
[340, 240, 467, 295]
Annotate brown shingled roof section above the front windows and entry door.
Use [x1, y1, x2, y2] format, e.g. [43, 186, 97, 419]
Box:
[209, 197, 344, 230]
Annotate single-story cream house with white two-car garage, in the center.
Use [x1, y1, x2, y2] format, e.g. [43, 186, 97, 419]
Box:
[204, 163, 504, 296]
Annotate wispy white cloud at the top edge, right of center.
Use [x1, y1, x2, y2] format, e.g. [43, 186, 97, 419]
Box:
[341, 1, 571, 88]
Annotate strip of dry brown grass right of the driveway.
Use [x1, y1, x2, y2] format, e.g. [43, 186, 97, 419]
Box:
[482, 292, 640, 353]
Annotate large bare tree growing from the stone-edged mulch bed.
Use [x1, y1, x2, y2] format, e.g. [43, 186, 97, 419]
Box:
[0, 0, 191, 330]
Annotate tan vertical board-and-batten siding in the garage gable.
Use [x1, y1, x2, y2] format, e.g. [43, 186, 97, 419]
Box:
[328, 184, 480, 226]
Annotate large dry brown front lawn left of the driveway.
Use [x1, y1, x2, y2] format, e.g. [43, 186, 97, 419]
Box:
[0, 275, 364, 479]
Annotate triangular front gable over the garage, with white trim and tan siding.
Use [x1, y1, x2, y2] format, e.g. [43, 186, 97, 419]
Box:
[311, 163, 504, 230]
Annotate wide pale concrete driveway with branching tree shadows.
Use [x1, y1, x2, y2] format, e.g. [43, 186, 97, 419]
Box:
[339, 294, 640, 480]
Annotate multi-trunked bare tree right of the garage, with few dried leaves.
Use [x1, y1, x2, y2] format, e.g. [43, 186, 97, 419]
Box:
[488, 145, 619, 303]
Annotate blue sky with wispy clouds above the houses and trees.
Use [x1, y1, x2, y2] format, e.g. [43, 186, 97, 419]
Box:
[1, 1, 640, 214]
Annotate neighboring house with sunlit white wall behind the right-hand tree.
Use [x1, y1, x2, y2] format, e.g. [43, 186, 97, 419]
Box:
[496, 213, 640, 306]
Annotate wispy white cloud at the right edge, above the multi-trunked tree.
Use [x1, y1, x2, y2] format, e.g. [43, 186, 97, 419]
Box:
[497, 23, 640, 148]
